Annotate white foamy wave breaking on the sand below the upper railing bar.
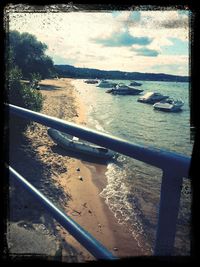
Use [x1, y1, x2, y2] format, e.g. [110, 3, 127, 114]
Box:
[100, 159, 152, 255]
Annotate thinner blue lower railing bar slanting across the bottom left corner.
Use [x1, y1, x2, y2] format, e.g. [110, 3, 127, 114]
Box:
[8, 166, 118, 260]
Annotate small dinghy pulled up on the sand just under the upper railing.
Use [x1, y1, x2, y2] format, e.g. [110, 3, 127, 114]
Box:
[47, 128, 117, 159]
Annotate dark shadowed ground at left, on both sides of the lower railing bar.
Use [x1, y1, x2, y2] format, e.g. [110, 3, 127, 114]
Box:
[8, 138, 70, 226]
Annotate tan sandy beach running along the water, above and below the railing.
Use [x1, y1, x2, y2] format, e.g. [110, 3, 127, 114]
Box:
[8, 78, 144, 262]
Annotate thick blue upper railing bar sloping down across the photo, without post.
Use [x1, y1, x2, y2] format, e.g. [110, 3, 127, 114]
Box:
[6, 104, 190, 178]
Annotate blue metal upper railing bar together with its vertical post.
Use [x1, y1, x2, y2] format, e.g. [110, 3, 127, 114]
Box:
[6, 104, 191, 256]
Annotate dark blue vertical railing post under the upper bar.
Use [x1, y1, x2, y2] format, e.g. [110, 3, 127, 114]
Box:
[154, 170, 183, 256]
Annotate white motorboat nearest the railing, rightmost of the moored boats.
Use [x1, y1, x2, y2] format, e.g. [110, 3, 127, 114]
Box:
[153, 98, 184, 112]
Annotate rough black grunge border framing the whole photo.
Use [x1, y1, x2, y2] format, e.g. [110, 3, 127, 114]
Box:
[0, 0, 200, 265]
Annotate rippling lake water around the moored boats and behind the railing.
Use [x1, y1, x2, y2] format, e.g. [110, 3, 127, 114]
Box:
[73, 80, 193, 255]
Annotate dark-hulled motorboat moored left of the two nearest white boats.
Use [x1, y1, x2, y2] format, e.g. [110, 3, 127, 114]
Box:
[106, 83, 143, 95]
